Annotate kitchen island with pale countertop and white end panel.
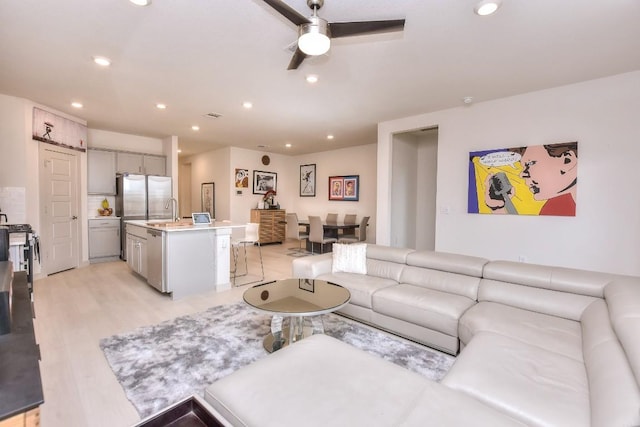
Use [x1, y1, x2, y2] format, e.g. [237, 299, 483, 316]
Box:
[125, 220, 245, 299]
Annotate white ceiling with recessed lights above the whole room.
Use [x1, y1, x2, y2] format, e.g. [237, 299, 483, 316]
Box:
[0, 0, 640, 155]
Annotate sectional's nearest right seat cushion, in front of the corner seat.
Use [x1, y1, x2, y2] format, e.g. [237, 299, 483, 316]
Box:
[442, 332, 590, 427]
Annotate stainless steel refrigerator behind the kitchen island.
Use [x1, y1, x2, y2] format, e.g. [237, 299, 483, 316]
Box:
[116, 174, 172, 260]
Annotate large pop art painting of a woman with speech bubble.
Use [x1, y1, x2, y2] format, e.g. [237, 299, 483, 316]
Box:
[468, 142, 578, 216]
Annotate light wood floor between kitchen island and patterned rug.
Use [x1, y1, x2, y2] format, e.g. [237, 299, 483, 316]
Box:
[34, 242, 298, 427]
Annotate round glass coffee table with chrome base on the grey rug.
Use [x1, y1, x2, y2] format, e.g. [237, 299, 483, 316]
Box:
[243, 279, 351, 353]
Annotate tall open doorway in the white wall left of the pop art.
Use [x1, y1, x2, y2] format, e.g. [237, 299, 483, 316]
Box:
[390, 127, 438, 250]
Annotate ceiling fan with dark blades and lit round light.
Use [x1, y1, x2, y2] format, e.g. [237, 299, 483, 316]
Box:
[264, 0, 404, 70]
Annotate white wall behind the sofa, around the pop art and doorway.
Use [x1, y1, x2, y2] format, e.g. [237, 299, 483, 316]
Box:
[377, 72, 640, 275]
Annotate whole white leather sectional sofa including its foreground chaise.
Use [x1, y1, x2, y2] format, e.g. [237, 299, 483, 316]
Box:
[205, 245, 640, 427]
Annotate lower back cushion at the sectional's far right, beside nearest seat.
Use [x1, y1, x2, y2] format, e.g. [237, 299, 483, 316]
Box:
[580, 298, 640, 427]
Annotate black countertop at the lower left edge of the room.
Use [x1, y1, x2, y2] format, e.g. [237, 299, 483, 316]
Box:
[0, 271, 44, 420]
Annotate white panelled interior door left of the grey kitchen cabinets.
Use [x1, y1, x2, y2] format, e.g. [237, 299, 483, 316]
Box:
[40, 144, 79, 274]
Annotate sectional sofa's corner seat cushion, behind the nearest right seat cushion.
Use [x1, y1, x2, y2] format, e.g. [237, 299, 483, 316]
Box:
[458, 301, 583, 362]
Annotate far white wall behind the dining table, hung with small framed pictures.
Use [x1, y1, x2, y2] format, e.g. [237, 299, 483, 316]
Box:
[180, 144, 376, 242]
